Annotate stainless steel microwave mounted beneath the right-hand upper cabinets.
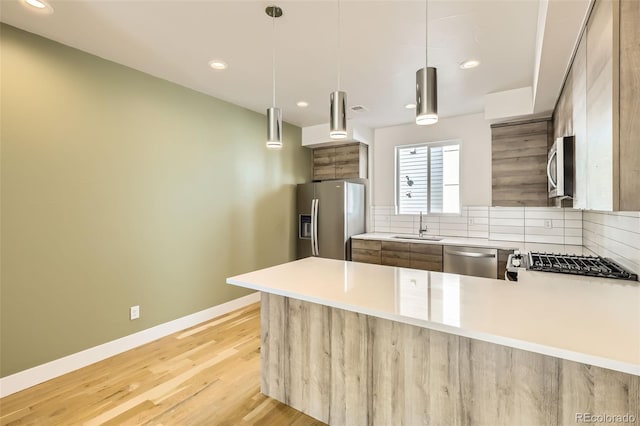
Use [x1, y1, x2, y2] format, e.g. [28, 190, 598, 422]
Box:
[547, 136, 574, 198]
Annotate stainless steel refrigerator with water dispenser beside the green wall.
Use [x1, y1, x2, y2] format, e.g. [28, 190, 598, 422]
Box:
[297, 180, 365, 260]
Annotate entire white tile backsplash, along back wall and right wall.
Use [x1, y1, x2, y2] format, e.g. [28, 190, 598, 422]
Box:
[372, 206, 640, 273]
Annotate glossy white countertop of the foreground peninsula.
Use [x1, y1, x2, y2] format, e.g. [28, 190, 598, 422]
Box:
[227, 257, 640, 375]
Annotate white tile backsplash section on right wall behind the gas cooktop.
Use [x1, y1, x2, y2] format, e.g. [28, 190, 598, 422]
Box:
[582, 211, 640, 274]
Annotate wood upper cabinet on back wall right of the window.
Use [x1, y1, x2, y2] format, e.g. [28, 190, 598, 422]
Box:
[491, 119, 553, 207]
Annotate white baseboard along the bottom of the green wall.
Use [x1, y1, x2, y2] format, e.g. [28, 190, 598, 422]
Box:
[0, 292, 260, 398]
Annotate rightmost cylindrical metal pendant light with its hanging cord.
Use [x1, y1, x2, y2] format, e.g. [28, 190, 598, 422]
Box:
[416, 0, 438, 125]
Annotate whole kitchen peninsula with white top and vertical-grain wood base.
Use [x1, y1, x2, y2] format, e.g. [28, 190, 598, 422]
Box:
[227, 258, 640, 425]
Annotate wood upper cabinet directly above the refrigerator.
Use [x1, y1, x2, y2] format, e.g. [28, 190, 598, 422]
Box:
[313, 143, 368, 180]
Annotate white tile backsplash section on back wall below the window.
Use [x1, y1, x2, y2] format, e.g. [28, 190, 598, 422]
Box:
[372, 206, 582, 245]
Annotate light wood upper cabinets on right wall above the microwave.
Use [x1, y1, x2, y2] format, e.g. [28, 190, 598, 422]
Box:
[554, 0, 640, 211]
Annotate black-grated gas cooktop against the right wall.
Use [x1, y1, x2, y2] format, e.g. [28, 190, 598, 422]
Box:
[527, 252, 638, 281]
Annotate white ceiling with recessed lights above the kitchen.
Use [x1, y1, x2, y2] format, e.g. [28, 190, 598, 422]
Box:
[0, 0, 588, 128]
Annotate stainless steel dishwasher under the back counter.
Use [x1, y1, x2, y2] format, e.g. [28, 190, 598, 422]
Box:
[442, 246, 498, 278]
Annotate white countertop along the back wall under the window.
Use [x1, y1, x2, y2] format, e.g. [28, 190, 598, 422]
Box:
[351, 232, 594, 255]
